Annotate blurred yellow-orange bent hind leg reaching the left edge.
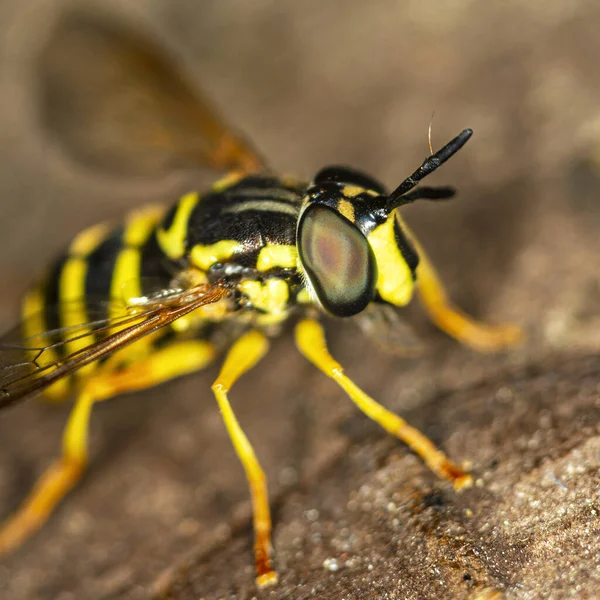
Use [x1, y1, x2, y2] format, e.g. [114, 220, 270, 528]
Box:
[0, 341, 214, 555]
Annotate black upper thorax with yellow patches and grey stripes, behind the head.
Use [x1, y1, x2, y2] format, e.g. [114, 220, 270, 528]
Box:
[157, 176, 305, 273]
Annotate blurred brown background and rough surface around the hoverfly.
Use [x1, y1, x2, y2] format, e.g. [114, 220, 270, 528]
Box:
[0, 0, 600, 600]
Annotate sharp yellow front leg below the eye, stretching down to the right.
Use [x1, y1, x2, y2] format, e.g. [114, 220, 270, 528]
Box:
[296, 319, 472, 490]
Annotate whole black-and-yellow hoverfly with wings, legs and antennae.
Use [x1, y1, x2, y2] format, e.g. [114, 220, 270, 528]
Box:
[0, 11, 520, 586]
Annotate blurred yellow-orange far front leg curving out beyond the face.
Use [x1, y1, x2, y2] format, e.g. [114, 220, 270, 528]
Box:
[402, 222, 523, 352]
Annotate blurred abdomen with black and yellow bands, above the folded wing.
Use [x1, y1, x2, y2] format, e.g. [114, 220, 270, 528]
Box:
[23, 207, 167, 398]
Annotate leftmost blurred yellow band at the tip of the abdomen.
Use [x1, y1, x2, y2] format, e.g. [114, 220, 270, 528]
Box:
[22, 288, 69, 401]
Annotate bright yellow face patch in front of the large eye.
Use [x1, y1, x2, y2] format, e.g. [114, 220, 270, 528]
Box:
[367, 214, 414, 306]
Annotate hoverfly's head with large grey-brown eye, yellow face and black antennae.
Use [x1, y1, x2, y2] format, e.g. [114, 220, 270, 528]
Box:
[296, 130, 471, 317]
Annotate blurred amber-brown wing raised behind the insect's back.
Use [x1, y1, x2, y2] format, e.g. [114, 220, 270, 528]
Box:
[38, 12, 264, 175]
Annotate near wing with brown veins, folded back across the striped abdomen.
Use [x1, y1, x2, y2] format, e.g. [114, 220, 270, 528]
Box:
[0, 283, 229, 408]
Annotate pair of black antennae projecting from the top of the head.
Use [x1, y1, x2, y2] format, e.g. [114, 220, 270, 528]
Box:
[386, 129, 473, 211]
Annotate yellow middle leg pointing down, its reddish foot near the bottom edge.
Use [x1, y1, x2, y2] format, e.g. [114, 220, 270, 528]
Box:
[212, 331, 277, 587]
